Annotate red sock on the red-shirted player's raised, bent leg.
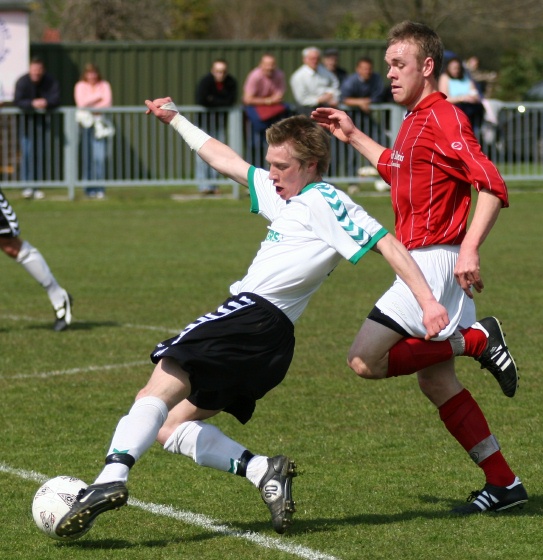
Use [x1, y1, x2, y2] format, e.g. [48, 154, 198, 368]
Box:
[387, 338, 453, 377]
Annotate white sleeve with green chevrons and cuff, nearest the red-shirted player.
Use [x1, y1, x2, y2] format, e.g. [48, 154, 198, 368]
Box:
[301, 183, 388, 264]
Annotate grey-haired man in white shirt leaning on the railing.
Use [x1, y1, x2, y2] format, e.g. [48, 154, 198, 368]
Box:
[290, 47, 340, 115]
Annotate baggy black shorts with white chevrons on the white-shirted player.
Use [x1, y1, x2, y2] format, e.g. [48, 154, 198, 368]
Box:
[151, 293, 294, 424]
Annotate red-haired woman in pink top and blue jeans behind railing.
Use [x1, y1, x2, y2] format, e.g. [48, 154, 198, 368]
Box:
[74, 62, 113, 199]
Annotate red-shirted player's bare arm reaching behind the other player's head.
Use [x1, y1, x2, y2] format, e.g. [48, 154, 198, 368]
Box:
[311, 107, 385, 167]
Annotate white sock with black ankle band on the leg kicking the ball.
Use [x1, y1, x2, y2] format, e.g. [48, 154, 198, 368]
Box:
[95, 397, 168, 484]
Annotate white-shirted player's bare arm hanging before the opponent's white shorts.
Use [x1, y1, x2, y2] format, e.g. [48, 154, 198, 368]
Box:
[377, 233, 449, 340]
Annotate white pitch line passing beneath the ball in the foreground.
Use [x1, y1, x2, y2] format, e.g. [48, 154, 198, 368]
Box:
[0, 463, 340, 560]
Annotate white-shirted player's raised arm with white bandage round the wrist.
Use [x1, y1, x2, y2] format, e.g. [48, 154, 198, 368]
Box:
[145, 97, 250, 186]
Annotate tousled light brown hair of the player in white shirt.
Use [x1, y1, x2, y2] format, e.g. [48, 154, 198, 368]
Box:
[266, 115, 331, 175]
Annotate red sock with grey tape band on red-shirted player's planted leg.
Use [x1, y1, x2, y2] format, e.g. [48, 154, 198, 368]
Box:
[439, 389, 515, 486]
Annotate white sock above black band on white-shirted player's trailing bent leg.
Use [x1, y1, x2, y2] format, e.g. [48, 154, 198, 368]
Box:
[164, 421, 246, 473]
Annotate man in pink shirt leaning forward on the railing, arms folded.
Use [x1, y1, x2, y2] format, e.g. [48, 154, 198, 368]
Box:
[243, 54, 288, 160]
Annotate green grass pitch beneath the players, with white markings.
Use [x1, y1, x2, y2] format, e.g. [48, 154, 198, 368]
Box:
[0, 189, 543, 560]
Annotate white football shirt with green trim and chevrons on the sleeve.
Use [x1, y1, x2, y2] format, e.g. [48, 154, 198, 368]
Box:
[230, 167, 388, 322]
